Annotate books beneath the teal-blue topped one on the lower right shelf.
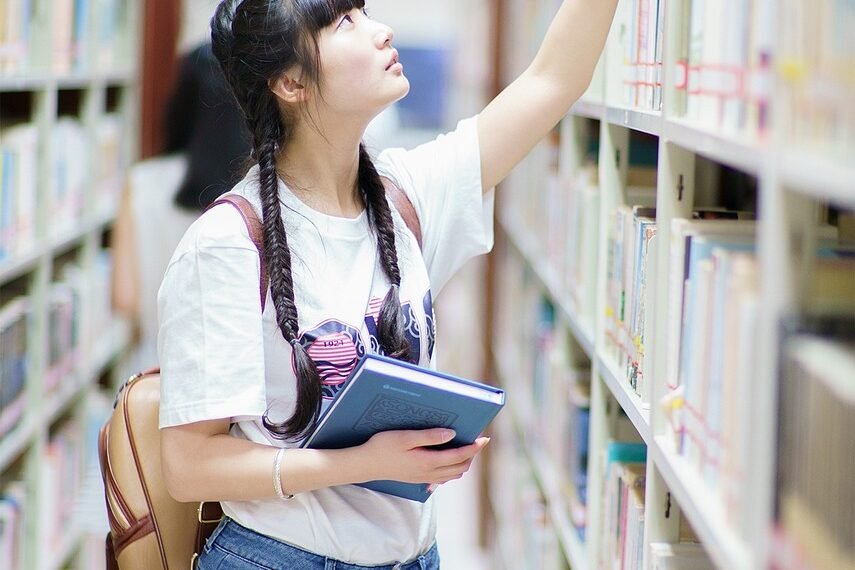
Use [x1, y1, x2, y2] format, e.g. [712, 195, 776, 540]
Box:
[597, 442, 647, 568]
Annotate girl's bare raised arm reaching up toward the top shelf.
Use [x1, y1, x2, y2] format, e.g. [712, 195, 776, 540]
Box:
[478, 0, 617, 192]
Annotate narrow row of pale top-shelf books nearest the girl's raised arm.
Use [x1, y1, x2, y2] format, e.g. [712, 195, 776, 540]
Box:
[607, 0, 665, 112]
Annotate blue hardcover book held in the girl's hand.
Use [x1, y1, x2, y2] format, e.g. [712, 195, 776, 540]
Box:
[302, 354, 505, 503]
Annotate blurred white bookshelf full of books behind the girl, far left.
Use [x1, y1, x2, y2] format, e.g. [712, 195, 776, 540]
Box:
[0, 0, 141, 570]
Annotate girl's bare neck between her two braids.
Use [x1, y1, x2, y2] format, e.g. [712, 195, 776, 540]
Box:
[277, 110, 366, 218]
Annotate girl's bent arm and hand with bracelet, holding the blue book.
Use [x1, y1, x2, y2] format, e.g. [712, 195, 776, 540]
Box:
[161, 420, 482, 503]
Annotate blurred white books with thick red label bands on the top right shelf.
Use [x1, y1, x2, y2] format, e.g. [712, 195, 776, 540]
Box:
[675, 0, 775, 135]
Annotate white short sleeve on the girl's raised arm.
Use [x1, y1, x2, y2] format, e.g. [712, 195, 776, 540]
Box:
[377, 117, 494, 294]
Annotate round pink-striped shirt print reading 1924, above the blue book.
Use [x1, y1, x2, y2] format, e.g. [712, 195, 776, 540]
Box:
[291, 319, 365, 400]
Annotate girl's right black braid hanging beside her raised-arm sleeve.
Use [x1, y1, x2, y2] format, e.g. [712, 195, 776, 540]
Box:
[359, 145, 412, 361]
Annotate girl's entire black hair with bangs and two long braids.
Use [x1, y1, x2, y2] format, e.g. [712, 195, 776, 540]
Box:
[211, 0, 412, 440]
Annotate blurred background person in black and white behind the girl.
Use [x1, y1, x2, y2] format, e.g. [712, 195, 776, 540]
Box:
[112, 43, 251, 371]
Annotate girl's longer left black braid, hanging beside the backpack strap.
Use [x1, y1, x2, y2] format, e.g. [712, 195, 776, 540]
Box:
[256, 105, 322, 439]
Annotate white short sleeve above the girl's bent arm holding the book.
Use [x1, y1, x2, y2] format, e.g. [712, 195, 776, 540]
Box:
[157, 206, 266, 428]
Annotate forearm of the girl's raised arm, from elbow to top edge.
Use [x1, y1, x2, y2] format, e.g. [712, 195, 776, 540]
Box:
[526, 0, 617, 98]
